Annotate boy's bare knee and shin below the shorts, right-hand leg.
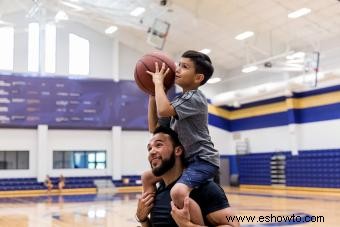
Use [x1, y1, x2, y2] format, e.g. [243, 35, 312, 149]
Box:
[170, 183, 204, 225]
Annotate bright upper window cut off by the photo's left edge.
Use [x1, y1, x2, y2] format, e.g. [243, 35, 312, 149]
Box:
[0, 27, 14, 70]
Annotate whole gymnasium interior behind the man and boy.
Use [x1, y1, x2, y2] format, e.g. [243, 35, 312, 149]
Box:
[0, 0, 340, 227]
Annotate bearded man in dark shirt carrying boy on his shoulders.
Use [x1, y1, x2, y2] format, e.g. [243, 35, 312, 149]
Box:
[136, 126, 239, 227]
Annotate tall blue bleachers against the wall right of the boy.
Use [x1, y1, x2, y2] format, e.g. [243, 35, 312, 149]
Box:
[238, 149, 340, 188]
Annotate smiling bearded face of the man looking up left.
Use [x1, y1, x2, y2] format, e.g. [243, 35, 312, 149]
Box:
[147, 133, 175, 176]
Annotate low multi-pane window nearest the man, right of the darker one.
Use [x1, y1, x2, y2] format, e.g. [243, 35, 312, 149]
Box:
[53, 151, 106, 169]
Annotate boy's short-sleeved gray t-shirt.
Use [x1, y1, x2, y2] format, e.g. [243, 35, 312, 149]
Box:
[158, 90, 220, 166]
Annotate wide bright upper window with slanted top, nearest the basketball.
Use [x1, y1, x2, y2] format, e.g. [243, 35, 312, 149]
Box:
[69, 34, 90, 75]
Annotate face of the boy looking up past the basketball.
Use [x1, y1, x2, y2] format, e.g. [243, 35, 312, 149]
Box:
[175, 58, 201, 90]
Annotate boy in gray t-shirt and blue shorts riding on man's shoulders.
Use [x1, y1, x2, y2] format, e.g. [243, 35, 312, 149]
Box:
[142, 50, 219, 224]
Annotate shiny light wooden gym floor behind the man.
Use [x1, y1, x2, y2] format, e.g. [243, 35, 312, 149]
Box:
[0, 187, 340, 227]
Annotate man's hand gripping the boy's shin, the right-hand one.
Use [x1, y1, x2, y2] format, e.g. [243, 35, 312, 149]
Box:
[171, 196, 192, 227]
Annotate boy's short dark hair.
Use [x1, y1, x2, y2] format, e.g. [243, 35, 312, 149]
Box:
[182, 50, 214, 85]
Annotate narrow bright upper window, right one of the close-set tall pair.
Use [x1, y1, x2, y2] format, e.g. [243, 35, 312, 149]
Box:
[45, 24, 57, 73]
